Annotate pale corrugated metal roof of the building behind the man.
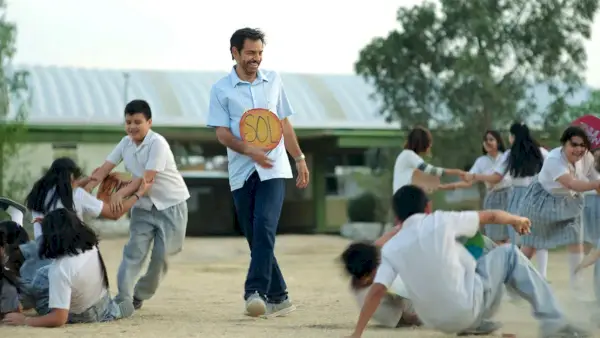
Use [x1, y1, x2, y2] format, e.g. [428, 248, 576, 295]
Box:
[12, 66, 398, 129]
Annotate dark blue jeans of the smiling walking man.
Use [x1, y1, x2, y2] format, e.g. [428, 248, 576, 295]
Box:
[233, 172, 287, 303]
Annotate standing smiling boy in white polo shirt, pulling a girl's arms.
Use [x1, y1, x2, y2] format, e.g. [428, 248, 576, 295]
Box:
[93, 100, 190, 309]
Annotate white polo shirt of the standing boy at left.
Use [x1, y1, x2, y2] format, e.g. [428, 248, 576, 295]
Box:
[106, 130, 190, 210]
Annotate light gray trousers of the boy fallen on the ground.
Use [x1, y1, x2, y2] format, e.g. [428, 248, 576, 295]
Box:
[470, 244, 567, 334]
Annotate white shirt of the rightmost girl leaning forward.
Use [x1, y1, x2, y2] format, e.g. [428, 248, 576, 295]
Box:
[538, 147, 600, 195]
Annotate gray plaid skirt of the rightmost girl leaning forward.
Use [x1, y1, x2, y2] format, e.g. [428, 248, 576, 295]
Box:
[517, 179, 583, 249]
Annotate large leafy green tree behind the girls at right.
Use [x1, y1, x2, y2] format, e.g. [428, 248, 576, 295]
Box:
[355, 0, 598, 167]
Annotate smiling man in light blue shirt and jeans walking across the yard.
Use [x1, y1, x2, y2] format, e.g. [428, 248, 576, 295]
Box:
[207, 28, 309, 317]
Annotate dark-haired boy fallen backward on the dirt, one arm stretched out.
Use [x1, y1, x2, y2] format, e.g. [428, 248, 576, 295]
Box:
[351, 185, 589, 337]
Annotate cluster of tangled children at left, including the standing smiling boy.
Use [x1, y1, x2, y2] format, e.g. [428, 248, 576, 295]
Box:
[0, 100, 189, 327]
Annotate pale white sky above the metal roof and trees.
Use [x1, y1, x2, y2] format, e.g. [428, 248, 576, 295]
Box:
[5, 0, 600, 87]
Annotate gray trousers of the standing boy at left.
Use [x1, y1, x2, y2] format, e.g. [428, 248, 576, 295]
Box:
[116, 201, 188, 302]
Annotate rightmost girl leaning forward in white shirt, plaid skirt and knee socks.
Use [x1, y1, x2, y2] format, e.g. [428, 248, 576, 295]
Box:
[518, 126, 600, 297]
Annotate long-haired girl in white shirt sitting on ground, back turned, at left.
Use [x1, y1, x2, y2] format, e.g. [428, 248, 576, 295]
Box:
[3, 208, 133, 327]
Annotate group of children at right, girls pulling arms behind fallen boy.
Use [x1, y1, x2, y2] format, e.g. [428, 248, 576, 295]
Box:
[342, 123, 600, 337]
